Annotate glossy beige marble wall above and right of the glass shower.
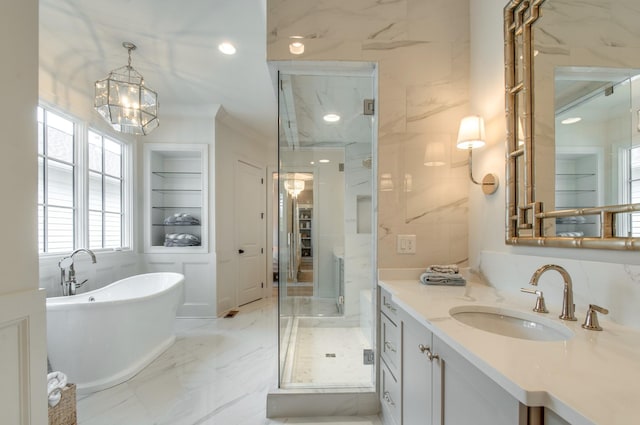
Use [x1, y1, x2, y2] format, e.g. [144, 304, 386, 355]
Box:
[267, 0, 469, 267]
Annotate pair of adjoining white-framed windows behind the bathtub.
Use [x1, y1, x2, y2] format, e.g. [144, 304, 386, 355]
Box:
[38, 107, 130, 254]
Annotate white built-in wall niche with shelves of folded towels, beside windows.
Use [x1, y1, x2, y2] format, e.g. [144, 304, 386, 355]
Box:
[144, 143, 208, 253]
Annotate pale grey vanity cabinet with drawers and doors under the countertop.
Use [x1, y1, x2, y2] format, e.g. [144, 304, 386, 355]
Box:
[380, 288, 528, 425]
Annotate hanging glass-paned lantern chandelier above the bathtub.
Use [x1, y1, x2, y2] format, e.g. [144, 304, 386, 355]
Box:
[94, 41, 159, 135]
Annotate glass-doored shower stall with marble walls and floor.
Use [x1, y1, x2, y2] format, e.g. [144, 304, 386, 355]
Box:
[275, 62, 376, 390]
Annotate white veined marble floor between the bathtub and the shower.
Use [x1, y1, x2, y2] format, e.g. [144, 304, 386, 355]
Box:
[78, 297, 380, 425]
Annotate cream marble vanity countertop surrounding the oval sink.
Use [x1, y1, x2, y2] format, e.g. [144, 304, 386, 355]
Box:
[380, 274, 640, 425]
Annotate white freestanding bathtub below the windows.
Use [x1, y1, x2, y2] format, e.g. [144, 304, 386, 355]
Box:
[47, 273, 184, 394]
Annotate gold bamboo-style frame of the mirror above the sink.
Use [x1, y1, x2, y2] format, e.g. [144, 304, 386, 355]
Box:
[504, 0, 640, 250]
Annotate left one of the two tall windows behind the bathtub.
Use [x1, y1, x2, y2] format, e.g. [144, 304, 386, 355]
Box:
[38, 108, 76, 253]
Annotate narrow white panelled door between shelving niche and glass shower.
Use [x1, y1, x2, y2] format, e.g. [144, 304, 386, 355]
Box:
[235, 161, 266, 305]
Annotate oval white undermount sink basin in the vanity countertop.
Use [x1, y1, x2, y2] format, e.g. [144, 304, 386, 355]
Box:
[449, 306, 573, 341]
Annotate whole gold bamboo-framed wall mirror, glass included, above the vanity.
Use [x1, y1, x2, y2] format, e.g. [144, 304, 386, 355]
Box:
[504, 0, 640, 250]
